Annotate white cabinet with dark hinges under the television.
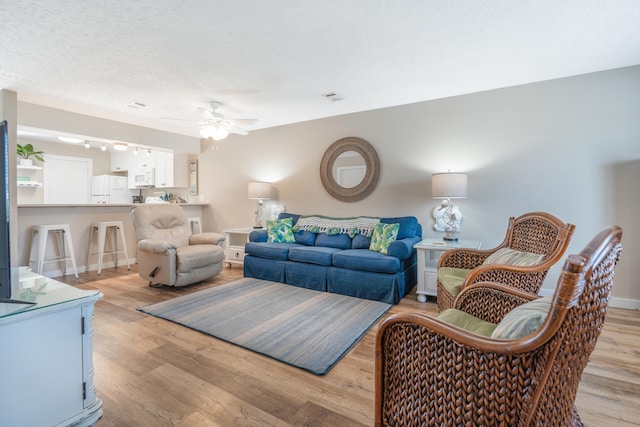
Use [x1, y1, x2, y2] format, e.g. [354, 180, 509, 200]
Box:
[0, 267, 102, 426]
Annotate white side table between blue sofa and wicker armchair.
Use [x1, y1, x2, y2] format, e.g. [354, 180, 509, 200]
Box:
[413, 238, 482, 302]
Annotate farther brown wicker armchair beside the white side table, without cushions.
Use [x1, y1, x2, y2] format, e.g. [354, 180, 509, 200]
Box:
[437, 212, 575, 311]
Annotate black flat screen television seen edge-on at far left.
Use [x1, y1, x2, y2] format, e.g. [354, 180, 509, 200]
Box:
[0, 120, 31, 304]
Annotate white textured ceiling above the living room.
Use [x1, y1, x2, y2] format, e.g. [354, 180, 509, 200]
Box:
[0, 0, 640, 136]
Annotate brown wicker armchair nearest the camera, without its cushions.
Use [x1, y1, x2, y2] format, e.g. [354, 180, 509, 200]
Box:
[375, 226, 622, 426]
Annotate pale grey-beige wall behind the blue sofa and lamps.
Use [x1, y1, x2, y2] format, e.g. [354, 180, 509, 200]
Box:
[199, 66, 640, 308]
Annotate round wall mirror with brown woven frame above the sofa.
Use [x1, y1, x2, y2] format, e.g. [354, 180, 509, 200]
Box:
[320, 137, 380, 202]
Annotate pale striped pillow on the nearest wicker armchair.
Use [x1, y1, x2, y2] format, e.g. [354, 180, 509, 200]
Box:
[491, 296, 553, 339]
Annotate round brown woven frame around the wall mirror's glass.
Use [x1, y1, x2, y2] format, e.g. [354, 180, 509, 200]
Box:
[320, 136, 380, 202]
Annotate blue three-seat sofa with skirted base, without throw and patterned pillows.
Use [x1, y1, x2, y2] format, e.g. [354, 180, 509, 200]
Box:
[244, 213, 422, 304]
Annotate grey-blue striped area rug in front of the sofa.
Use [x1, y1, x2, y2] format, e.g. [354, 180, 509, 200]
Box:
[138, 278, 391, 375]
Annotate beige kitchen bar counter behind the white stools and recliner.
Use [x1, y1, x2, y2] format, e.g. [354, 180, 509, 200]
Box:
[17, 203, 210, 277]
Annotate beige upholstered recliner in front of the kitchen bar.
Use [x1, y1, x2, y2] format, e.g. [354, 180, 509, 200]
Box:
[131, 204, 224, 286]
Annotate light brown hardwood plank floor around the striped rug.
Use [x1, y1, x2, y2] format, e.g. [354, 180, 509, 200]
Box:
[57, 267, 640, 427]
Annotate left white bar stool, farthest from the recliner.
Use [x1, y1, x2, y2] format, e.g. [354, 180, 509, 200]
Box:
[29, 224, 78, 279]
